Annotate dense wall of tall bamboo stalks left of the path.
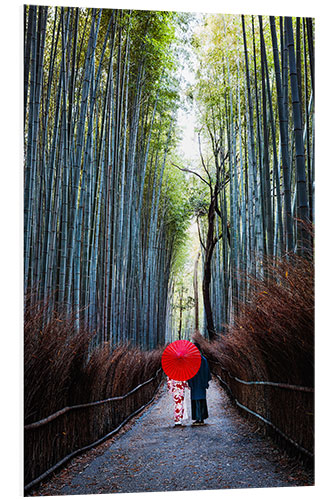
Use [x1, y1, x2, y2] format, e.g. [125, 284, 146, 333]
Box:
[24, 6, 192, 348]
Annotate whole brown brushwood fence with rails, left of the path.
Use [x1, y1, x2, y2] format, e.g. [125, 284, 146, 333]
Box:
[24, 301, 162, 491]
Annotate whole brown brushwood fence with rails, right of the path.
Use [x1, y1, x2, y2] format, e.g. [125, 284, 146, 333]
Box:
[193, 252, 314, 466]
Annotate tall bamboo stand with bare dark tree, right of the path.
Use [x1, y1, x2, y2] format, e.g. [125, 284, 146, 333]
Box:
[191, 15, 314, 339]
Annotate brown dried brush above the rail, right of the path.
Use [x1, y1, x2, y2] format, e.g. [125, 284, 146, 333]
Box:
[193, 256, 314, 387]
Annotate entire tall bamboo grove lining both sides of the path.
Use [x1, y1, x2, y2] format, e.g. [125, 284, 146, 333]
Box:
[24, 6, 315, 349]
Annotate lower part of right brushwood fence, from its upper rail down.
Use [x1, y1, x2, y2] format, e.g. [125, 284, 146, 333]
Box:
[209, 361, 314, 462]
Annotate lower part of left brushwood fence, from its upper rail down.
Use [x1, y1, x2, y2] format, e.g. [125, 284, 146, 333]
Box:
[24, 368, 163, 492]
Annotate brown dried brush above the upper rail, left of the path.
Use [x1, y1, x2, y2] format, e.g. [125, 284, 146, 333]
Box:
[24, 296, 162, 424]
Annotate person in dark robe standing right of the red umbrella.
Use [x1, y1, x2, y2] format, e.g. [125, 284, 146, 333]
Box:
[188, 342, 212, 425]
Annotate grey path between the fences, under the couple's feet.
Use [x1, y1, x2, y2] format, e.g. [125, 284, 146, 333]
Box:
[28, 380, 314, 496]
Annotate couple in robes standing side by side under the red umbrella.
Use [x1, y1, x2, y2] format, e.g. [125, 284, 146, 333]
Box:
[167, 342, 212, 426]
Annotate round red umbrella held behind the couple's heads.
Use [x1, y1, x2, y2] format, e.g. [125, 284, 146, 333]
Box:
[161, 340, 201, 380]
